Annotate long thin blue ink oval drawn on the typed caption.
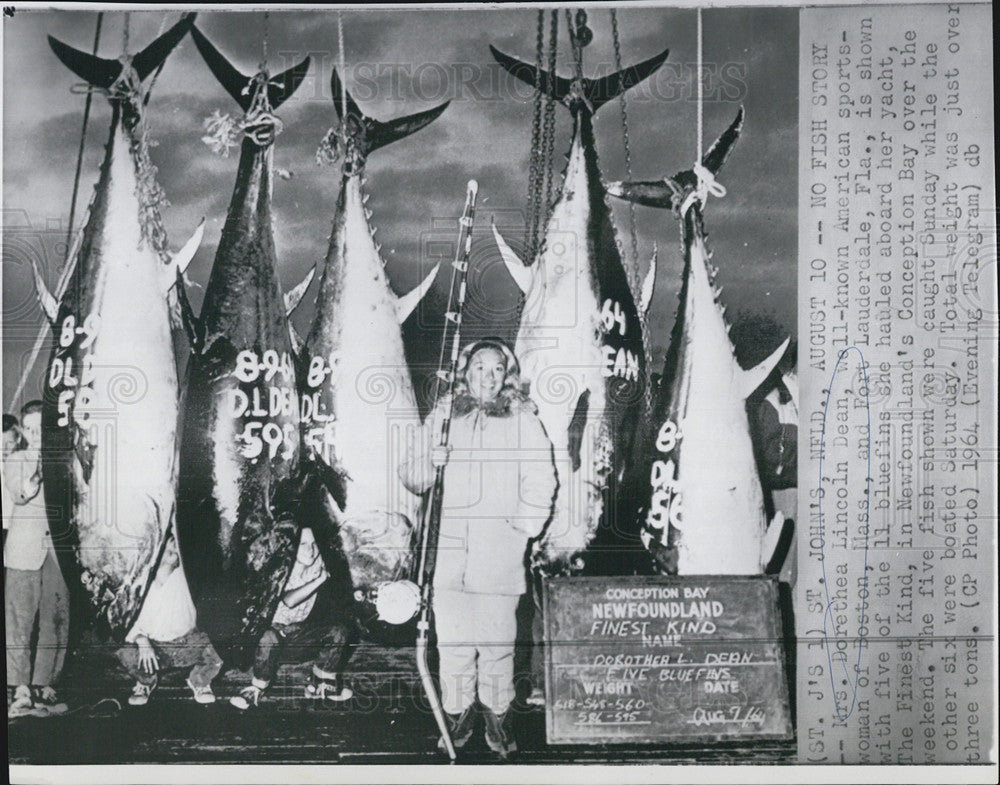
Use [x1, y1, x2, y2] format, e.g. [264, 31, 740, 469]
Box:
[818, 346, 872, 722]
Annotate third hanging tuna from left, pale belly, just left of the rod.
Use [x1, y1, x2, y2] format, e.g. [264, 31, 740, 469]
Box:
[299, 70, 448, 590]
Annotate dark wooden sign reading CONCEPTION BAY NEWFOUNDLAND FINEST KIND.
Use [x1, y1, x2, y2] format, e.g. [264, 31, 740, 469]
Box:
[544, 576, 793, 744]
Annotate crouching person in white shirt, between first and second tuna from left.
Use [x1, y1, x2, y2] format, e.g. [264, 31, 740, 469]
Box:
[116, 532, 222, 706]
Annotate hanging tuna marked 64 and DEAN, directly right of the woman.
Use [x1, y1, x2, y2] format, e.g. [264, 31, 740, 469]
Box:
[491, 47, 668, 571]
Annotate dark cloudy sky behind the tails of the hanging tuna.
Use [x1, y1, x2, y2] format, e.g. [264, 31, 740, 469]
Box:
[3, 8, 798, 410]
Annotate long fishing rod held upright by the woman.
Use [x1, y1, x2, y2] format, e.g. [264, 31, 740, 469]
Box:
[417, 180, 479, 760]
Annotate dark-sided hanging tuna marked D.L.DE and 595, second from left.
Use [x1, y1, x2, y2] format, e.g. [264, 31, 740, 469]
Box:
[177, 28, 326, 667]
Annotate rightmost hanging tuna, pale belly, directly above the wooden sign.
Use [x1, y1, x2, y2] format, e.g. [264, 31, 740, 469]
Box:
[608, 109, 788, 575]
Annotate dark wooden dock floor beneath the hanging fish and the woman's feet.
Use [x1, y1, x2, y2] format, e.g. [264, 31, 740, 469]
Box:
[8, 632, 794, 764]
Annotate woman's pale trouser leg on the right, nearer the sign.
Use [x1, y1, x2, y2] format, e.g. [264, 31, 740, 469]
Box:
[472, 594, 520, 715]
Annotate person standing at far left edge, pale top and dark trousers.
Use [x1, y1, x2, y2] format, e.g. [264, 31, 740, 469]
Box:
[3, 401, 69, 717]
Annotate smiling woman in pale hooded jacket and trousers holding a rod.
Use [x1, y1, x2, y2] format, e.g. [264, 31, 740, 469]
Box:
[400, 338, 556, 758]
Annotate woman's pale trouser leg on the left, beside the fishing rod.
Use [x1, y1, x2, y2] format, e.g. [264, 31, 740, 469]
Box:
[434, 589, 476, 714]
